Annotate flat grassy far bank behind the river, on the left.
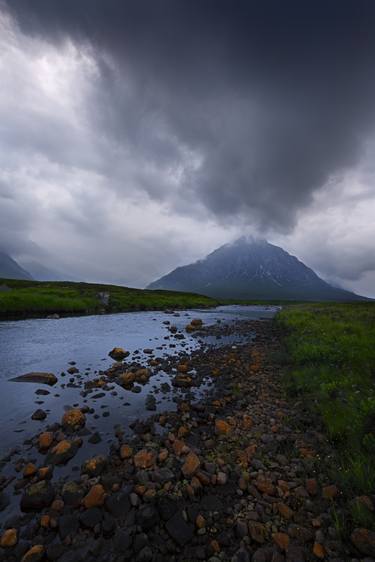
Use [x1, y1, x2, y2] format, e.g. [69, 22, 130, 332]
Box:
[0, 279, 218, 319]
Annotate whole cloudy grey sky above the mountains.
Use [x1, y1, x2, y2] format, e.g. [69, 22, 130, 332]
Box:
[0, 0, 375, 297]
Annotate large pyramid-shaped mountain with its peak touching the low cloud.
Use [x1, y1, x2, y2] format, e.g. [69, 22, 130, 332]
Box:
[147, 237, 365, 301]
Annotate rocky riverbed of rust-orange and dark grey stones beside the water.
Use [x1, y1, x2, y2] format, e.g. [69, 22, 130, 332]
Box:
[0, 321, 374, 562]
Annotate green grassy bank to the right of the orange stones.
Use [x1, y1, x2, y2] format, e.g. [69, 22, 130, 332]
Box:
[276, 303, 375, 529]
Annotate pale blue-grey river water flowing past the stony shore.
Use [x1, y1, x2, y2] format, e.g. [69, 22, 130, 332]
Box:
[0, 306, 277, 454]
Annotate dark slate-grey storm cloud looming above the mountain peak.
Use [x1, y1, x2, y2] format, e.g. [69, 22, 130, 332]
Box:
[7, 0, 375, 230]
